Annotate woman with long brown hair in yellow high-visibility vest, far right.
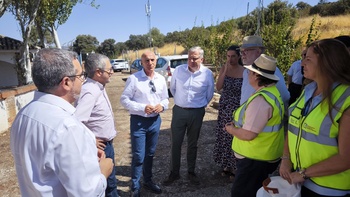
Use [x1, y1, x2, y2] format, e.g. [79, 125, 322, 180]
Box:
[280, 39, 350, 197]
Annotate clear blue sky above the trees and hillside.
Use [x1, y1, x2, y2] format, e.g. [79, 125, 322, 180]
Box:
[0, 0, 335, 46]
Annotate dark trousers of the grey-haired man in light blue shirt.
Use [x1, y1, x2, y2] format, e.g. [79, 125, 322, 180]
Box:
[170, 105, 205, 174]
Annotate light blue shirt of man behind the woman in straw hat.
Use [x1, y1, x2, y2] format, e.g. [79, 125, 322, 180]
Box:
[240, 67, 290, 107]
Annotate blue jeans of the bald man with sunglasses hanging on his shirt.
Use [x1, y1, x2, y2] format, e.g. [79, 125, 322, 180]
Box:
[130, 115, 161, 191]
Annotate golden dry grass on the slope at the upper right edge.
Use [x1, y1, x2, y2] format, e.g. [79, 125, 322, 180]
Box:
[293, 14, 350, 42]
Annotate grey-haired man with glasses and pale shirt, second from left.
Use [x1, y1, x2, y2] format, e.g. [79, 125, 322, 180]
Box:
[75, 53, 118, 197]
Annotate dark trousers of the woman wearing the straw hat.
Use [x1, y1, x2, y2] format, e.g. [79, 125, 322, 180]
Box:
[231, 158, 279, 197]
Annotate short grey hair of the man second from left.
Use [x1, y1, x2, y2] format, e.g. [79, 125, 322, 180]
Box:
[84, 53, 109, 78]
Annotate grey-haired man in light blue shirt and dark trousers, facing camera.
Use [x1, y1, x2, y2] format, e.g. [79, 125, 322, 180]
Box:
[163, 46, 214, 185]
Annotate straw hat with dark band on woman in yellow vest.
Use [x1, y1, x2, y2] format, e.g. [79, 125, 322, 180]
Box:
[244, 54, 280, 81]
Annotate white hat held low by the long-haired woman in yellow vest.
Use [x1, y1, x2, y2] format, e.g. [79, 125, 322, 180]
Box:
[256, 176, 301, 197]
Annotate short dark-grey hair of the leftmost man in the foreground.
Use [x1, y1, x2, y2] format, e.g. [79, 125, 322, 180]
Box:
[32, 48, 77, 92]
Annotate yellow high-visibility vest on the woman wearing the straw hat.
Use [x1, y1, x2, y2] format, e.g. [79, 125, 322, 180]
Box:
[232, 86, 284, 161]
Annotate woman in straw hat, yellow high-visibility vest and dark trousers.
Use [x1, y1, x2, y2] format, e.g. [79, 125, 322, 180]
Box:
[225, 54, 284, 197]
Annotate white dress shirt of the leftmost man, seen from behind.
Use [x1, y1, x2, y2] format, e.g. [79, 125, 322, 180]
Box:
[10, 92, 106, 197]
